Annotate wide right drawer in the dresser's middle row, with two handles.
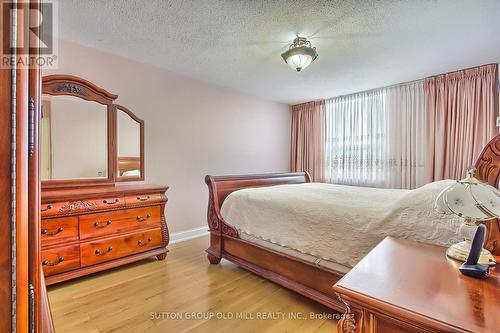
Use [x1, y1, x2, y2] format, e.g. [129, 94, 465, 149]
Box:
[80, 206, 161, 239]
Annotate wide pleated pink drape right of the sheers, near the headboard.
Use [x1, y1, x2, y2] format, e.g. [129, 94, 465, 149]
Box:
[424, 64, 498, 182]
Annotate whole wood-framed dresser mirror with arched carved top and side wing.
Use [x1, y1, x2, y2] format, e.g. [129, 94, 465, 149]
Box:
[40, 75, 144, 188]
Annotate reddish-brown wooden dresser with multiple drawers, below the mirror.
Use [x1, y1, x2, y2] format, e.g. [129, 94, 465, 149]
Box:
[40, 185, 169, 285]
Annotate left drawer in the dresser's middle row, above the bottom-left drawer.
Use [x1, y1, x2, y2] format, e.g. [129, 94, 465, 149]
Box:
[40, 216, 78, 246]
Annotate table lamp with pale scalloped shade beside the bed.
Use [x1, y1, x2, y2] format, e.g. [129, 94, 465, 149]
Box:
[434, 168, 500, 265]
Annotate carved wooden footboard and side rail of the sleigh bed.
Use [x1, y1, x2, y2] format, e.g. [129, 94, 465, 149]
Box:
[205, 172, 344, 311]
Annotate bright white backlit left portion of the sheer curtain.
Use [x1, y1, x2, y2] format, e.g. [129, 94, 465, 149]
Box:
[325, 90, 389, 187]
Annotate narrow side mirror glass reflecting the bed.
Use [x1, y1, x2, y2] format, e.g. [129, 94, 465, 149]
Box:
[116, 109, 141, 178]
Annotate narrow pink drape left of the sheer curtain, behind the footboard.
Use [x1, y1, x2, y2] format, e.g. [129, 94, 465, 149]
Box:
[290, 101, 326, 182]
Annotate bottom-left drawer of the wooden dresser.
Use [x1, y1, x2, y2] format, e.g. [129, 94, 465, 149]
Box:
[41, 245, 80, 276]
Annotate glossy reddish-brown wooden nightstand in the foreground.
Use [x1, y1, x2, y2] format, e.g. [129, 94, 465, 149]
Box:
[333, 237, 500, 333]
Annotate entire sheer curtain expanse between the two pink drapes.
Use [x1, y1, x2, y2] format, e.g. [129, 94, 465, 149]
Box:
[325, 81, 426, 188]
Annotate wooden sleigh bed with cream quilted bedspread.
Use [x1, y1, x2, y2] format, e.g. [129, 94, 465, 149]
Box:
[205, 135, 500, 311]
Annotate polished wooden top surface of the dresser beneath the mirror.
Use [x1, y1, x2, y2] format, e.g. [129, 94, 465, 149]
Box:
[42, 184, 168, 203]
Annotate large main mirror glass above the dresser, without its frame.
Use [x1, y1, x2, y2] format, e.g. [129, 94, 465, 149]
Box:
[41, 94, 108, 180]
